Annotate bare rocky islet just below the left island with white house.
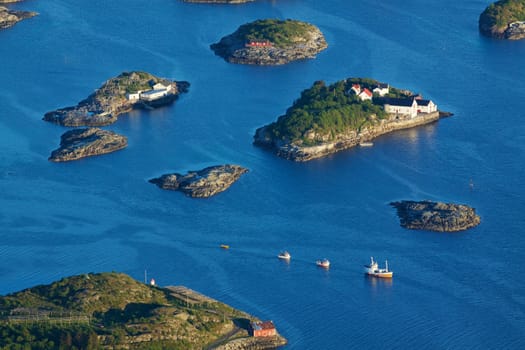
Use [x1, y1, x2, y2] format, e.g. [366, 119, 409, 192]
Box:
[49, 128, 128, 162]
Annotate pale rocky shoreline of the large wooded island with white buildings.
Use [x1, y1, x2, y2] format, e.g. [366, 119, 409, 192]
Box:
[253, 112, 451, 162]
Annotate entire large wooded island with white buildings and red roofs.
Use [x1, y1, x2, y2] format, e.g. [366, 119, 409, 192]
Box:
[254, 78, 451, 161]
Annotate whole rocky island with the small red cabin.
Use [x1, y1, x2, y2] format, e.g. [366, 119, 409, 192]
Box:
[211, 19, 328, 65]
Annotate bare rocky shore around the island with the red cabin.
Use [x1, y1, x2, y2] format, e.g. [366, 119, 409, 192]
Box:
[210, 21, 328, 65]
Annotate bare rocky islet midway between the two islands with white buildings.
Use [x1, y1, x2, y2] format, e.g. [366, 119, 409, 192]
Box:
[149, 164, 248, 198]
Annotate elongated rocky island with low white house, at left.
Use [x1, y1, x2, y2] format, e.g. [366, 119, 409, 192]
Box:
[43, 72, 189, 127]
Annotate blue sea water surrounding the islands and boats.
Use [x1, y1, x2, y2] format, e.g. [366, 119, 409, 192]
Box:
[0, 0, 525, 349]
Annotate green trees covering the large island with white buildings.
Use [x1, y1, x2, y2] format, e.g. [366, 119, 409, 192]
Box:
[266, 78, 410, 145]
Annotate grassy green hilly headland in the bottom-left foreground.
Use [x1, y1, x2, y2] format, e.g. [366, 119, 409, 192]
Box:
[0, 272, 286, 350]
